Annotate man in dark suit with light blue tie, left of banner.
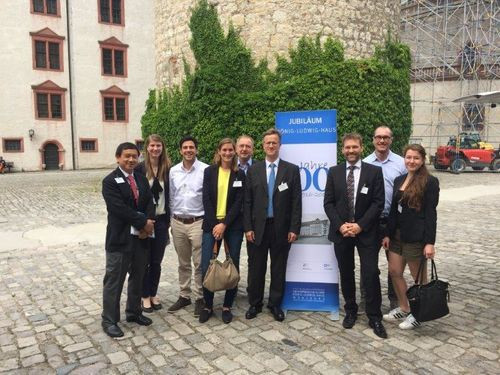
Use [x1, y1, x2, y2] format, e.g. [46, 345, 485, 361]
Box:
[243, 129, 302, 321]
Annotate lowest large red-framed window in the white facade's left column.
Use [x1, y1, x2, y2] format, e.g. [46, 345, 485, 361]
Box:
[32, 81, 66, 121]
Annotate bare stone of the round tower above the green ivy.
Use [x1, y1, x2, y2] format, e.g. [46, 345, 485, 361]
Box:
[155, 0, 400, 87]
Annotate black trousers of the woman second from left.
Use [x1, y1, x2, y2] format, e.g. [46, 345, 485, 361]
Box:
[142, 215, 168, 298]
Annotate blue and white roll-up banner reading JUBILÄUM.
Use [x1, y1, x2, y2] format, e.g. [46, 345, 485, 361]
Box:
[276, 109, 339, 320]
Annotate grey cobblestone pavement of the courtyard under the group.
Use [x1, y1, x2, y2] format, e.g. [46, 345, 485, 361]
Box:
[0, 170, 500, 374]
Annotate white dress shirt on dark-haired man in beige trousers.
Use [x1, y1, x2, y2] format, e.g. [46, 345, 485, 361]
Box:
[169, 159, 208, 218]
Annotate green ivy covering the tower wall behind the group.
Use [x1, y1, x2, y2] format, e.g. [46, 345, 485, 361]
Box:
[142, 0, 411, 162]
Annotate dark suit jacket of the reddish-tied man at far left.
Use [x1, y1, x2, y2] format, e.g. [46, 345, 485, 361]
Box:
[102, 168, 154, 252]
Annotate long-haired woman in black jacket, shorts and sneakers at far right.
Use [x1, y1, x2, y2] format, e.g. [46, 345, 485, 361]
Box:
[382, 144, 439, 329]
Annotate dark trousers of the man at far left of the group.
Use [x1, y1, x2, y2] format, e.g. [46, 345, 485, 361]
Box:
[101, 236, 149, 327]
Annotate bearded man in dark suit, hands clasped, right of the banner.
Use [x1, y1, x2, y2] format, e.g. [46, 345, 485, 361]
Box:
[324, 133, 387, 338]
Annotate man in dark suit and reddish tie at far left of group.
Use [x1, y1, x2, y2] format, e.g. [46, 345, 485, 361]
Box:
[101, 142, 154, 337]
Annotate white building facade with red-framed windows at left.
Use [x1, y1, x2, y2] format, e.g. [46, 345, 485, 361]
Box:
[0, 0, 154, 171]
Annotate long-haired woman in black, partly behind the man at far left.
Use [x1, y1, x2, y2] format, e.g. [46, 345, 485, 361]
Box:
[135, 134, 172, 313]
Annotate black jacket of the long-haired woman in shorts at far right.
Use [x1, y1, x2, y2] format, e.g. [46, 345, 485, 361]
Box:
[387, 174, 439, 245]
